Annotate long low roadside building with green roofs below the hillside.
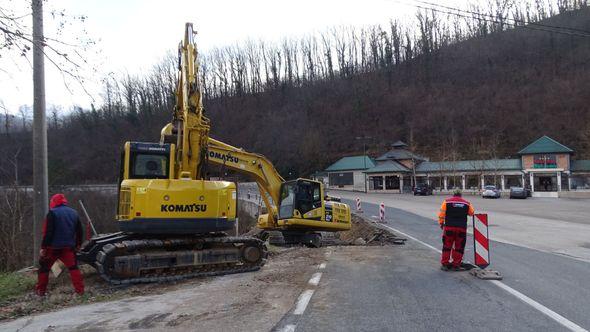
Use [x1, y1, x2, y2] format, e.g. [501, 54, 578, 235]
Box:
[326, 136, 590, 197]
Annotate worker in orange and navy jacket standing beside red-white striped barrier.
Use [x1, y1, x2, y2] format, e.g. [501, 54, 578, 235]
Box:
[438, 190, 475, 271]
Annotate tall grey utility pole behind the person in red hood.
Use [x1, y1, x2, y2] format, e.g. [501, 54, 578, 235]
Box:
[31, 0, 49, 264]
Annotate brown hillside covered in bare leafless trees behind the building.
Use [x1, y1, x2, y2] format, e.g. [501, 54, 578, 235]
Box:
[0, 0, 590, 184]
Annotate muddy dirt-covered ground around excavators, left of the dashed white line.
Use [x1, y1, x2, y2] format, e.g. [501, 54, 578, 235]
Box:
[0, 217, 402, 331]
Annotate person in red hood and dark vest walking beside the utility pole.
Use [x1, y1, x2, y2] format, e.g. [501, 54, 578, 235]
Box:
[35, 194, 84, 296]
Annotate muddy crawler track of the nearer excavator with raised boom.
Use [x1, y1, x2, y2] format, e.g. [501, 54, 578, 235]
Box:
[84, 234, 267, 285]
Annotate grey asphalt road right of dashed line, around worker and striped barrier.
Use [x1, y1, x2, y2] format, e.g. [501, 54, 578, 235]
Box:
[297, 201, 590, 331]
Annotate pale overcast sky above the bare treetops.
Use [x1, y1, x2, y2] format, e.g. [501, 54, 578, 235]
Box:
[0, 0, 467, 112]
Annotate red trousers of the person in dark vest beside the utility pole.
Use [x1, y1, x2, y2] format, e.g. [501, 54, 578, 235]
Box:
[35, 248, 84, 295]
